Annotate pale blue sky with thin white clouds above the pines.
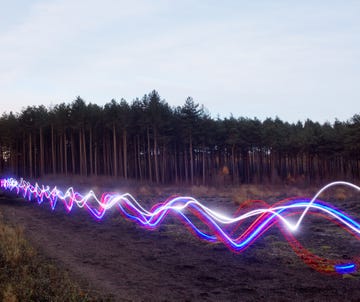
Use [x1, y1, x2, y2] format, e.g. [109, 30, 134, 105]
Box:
[0, 0, 360, 122]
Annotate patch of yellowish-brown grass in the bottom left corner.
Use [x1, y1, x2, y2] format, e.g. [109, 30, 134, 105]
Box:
[0, 212, 111, 302]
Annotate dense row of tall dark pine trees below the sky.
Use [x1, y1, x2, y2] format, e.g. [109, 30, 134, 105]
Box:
[0, 91, 360, 185]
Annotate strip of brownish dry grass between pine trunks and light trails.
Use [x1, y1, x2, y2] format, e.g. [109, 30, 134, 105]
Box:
[23, 175, 356, 208]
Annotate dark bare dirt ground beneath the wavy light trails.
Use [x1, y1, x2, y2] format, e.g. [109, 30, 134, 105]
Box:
[0, 189, 360, 301]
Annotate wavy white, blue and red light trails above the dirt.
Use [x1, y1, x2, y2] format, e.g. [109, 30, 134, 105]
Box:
[1, 178, 360, 274]
